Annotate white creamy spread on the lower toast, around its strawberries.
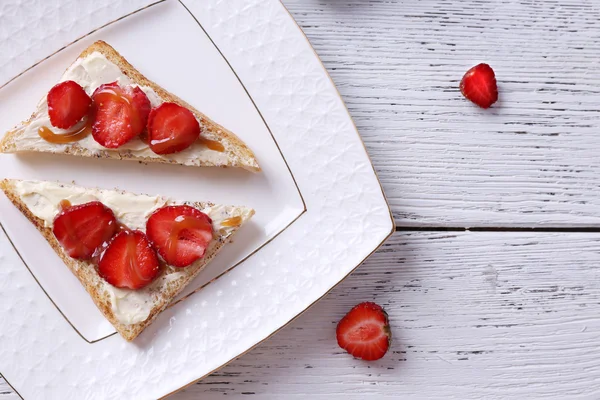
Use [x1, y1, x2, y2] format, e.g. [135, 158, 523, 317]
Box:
[15, 181, 252, 325]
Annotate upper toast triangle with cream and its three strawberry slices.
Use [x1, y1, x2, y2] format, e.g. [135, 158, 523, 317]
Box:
[0, 41, 260, 172]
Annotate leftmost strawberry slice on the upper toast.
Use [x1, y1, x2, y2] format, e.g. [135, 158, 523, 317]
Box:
[46, 81, 92, 129]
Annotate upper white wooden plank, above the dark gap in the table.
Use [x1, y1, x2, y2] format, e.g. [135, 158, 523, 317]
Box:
[284, 0, 600, 227]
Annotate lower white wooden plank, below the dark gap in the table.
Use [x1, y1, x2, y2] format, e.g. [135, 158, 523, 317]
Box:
[5, 232, 600, 400]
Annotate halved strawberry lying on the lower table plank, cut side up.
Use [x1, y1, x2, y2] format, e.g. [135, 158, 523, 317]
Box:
[336, 302, 392, 361]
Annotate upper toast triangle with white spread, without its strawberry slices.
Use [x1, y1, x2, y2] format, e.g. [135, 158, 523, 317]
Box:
[0, 41, 260, 172]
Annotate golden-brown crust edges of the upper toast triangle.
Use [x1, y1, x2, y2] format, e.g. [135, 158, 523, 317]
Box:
[0, 40, 261, 172]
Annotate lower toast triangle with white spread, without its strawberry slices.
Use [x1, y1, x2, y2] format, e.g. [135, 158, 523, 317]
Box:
[0, 179, 254, 340]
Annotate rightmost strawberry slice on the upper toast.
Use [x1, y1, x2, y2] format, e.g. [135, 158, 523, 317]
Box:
[148, 103, 200, 154]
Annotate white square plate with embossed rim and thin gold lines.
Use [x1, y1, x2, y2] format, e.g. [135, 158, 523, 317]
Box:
[0, 0, 394, 399]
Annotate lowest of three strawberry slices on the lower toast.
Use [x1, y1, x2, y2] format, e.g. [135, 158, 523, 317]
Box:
[98, 230, 160, 289]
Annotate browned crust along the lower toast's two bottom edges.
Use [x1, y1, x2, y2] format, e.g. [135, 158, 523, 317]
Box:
[0, 179, 254, 341]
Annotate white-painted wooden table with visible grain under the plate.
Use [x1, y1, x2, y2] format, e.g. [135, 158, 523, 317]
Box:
[0, 0, 600, 400]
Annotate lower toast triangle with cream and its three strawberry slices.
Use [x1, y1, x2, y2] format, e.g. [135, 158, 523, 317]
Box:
[0, 179, 254, 340]
